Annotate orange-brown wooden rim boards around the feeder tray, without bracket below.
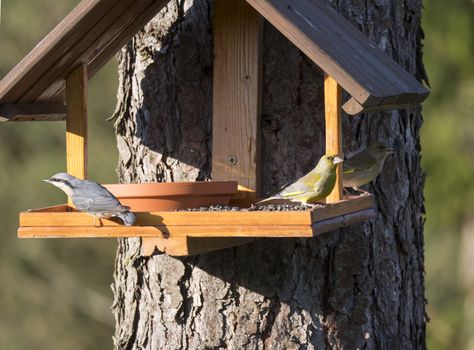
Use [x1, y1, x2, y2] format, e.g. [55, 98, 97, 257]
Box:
[18, 195, 372, 238]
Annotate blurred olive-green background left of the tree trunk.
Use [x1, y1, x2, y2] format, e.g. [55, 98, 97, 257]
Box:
[0, 0, 117, 350]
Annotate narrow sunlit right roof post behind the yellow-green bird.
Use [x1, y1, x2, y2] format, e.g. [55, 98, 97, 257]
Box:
[324, 74, 342, 203]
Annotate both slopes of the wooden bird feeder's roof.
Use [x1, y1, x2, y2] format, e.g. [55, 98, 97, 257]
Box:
[0, 0, 429, 120]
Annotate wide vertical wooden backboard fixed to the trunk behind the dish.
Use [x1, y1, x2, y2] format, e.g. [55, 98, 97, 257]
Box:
[212, 0, 262, 195]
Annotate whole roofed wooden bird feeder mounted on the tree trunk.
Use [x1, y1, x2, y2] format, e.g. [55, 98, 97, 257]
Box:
[0, 0, 429, 255]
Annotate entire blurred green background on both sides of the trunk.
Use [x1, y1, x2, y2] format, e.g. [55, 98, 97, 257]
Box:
[0, 0, 474, 350]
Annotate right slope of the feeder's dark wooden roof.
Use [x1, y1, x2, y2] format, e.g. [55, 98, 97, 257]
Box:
[247, 0, 429, 109]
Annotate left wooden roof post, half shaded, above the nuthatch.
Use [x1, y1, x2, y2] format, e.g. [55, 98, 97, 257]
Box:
[66, 64, 87, 204]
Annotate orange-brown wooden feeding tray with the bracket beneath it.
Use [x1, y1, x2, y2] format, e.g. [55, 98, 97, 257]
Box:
[18, 194, 374, 256]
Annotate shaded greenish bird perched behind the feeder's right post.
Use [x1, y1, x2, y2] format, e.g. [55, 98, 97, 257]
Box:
[342, 143, 395, 191]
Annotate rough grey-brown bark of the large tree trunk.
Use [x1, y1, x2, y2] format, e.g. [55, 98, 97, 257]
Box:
[113, 0, 426, 349]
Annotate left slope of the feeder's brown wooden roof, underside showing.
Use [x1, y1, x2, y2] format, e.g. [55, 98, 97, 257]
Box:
[0, 0, 168, 103]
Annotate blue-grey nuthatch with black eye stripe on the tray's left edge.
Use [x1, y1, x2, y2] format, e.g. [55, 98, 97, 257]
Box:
[43, 173, 135, 226]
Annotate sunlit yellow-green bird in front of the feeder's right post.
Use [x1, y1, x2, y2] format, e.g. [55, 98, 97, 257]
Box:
[257, 154, 343, 205]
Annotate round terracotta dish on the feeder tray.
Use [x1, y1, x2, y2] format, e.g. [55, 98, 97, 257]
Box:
[104, 181, 237, 211]
